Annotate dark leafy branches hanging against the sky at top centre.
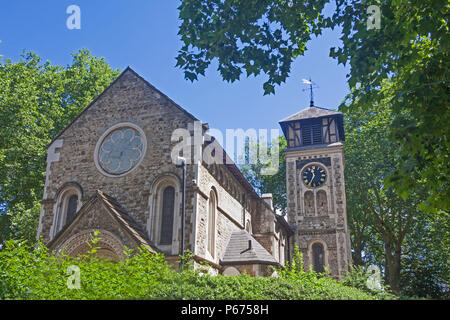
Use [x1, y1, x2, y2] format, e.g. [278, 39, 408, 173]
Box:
[177, 0, 326, 94]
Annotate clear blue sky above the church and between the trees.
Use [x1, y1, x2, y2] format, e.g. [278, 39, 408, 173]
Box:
[0, 0, 349, 133]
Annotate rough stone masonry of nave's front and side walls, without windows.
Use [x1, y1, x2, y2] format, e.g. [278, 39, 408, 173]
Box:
[38, 68, 289, 275]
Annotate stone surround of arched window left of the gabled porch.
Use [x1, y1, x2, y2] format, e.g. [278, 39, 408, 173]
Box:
[50, 183, 83, 239]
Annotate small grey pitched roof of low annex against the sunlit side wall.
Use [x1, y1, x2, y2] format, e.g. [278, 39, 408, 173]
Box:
[220, 230, 279, 265]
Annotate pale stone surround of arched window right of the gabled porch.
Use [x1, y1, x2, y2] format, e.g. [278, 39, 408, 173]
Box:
[147, 173, 181, 255]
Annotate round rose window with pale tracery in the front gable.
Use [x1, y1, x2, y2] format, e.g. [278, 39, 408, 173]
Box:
[98, 127, 144, 175]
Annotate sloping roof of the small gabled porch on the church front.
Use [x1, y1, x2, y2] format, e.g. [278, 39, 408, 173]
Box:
[47, 190, 159, 252]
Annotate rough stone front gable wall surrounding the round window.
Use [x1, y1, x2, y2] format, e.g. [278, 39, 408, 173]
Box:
[40, 69, 196, 255]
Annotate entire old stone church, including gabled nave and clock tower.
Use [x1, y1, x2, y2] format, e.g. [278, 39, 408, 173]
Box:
[38, 68, 350, 276]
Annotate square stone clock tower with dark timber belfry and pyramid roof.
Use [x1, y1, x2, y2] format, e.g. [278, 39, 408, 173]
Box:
[280, 101, 351, 278]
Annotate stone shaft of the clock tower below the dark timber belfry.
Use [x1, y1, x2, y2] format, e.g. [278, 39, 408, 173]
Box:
[286, 143, 351, 276]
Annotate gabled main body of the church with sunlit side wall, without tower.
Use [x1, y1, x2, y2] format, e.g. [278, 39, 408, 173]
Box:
[38, 69, 292, 276]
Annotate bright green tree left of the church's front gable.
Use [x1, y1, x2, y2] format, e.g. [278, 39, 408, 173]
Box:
[0, 49, 118, 240]
